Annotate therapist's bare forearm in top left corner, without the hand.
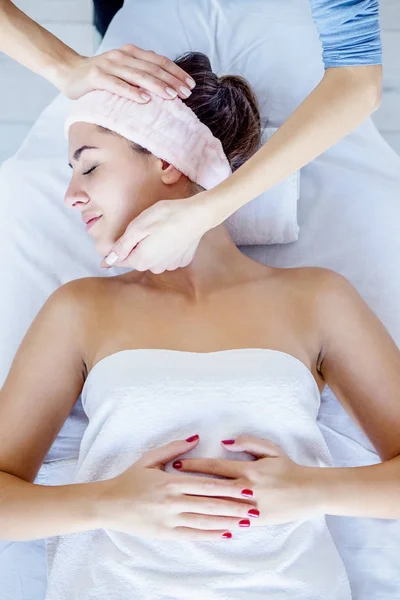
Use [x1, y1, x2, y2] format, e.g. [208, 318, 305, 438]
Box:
[0, 0, 80, 89]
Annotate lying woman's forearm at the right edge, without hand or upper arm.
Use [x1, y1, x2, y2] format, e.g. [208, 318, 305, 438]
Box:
[312, 457, 400, 519]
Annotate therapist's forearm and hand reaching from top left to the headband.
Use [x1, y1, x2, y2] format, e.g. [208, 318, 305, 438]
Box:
[0, 0, 195, 103]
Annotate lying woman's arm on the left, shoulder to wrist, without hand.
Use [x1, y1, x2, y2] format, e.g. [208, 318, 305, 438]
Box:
[0, 283, 103, 540]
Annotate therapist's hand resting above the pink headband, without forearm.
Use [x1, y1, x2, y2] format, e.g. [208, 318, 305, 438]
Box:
[58, 44, 196, 104]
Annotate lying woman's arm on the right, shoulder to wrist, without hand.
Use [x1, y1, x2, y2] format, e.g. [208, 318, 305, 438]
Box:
[312, 272, 400, 519]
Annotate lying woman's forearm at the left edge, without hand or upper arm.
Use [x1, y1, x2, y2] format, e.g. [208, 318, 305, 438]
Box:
[0, 472, 105, 541]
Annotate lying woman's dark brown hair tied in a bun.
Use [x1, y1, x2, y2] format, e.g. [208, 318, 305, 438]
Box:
[174, 52, 261, 171]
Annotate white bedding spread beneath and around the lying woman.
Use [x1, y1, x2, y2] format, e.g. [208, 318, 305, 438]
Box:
[0, 0, 400, 600]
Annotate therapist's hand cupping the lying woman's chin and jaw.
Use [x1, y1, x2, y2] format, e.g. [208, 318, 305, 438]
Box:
[101, 192, 216, 274]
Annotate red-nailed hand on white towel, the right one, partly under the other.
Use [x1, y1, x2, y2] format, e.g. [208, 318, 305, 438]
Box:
[173, 435, 323, 526]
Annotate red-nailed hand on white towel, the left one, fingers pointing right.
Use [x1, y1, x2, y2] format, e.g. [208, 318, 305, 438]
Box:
[94, 437, 256, 541]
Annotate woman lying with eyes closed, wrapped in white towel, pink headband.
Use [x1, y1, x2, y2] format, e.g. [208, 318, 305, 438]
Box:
[0, 53, 400, 600]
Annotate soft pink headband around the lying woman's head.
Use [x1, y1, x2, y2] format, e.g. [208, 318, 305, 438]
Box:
[64, 90, 232, 189]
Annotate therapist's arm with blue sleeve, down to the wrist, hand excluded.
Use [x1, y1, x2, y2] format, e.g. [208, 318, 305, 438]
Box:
[204, 0, 382, 223]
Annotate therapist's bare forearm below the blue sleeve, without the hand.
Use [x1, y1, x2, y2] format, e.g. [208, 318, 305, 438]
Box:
[204, 65, 382, 225]
